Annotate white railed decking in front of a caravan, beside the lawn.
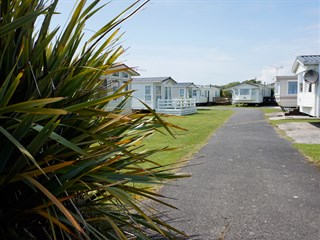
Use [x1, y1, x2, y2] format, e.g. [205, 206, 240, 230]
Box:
[156, 98, 197, 116]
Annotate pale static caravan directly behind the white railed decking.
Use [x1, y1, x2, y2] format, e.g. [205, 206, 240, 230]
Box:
[132, 77, 177, 110]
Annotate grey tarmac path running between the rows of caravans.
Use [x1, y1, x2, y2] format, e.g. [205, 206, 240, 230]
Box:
[156, 108, 320, 240]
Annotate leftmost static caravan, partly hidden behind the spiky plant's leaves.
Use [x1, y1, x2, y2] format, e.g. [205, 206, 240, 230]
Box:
[101, 64, 140, 113]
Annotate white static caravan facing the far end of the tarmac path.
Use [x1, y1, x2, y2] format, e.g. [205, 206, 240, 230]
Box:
[228, 83, 271, 105]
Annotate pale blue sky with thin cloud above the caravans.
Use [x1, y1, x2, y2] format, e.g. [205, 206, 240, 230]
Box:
[54, 0, 320, 85]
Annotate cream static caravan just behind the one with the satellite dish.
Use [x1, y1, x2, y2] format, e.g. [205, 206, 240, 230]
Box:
[274, 76, 298, 109]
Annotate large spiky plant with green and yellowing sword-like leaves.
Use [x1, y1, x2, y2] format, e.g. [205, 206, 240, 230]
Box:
[0, 0, 189, 239]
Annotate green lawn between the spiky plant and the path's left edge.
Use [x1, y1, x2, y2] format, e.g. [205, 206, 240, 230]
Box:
[144, 110, 233, 169]
